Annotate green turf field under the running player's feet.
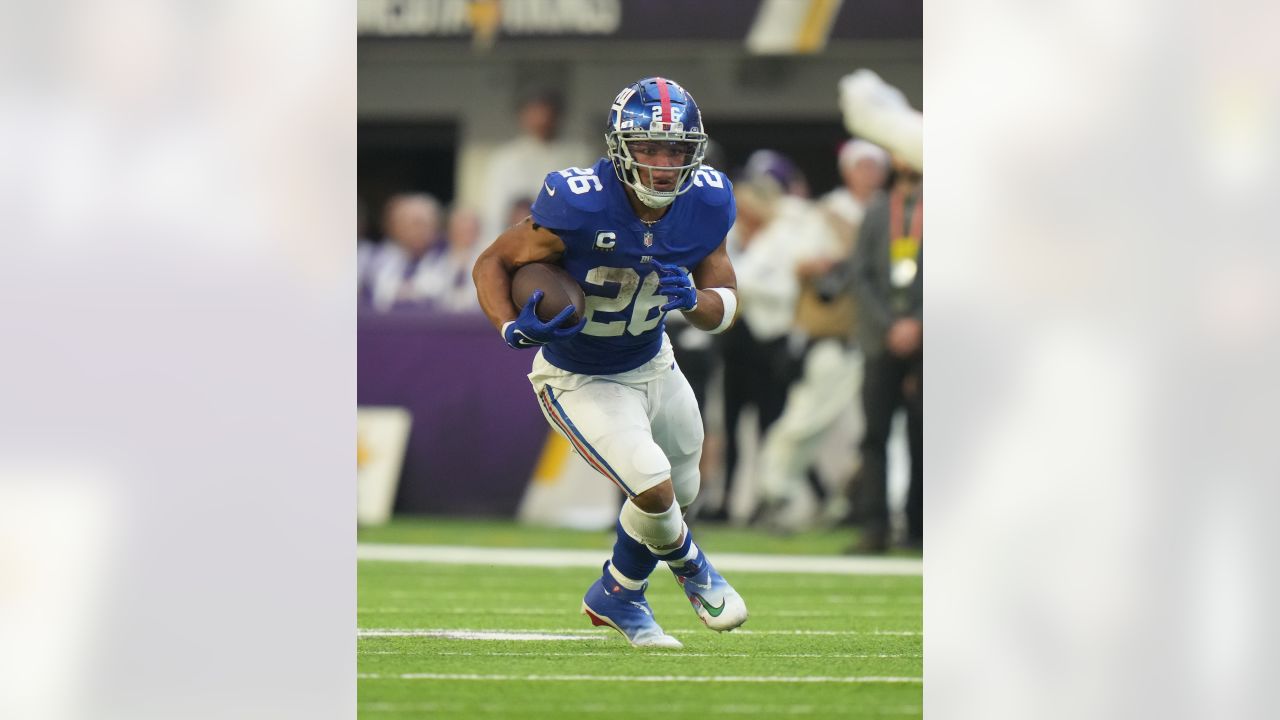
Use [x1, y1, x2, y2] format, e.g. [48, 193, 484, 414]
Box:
[357, 521, 923, 719]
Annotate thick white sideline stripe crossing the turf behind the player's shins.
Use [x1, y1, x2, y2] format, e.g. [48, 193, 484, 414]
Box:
[356, 543, 924, 575]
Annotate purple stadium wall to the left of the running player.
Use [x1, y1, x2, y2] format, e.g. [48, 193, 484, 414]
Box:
[356, 311, 548, 516]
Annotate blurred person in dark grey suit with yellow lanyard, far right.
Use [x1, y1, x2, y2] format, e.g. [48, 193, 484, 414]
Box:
[852, 155, 924, 552]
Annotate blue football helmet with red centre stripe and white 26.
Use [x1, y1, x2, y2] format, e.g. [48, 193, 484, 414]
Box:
[604, 77, 707, 208]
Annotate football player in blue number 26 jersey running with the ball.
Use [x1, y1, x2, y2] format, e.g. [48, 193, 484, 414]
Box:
[474, 77, 748, 647]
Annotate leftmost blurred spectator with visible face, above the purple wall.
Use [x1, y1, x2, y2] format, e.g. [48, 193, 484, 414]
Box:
[361, 193, 440, 310]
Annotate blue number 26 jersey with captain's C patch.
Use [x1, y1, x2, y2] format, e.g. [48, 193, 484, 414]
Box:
[532, 158, 736, 375]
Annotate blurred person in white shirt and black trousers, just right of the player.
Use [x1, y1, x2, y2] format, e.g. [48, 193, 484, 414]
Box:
[700, 150, 828, 520]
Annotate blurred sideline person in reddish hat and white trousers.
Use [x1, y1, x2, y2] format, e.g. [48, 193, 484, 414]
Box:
[744, 140, 888, 530]
